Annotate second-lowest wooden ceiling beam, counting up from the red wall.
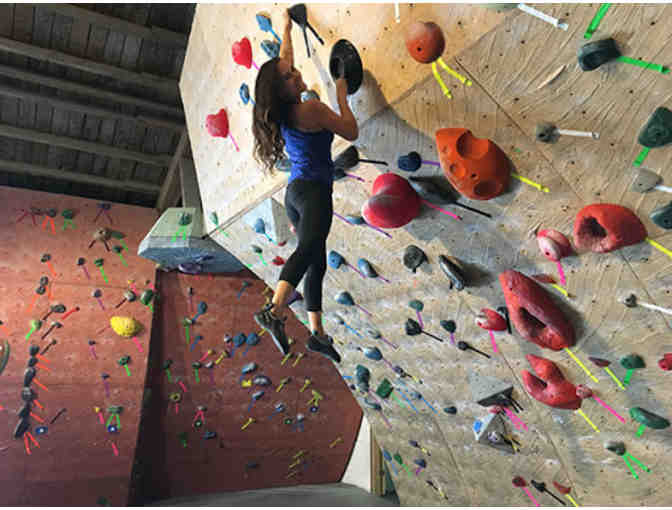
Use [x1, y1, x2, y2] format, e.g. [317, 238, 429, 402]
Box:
[0, 85, 185, 131]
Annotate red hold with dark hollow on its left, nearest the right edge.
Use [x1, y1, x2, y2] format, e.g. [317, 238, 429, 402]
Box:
[574, 204, 647, 253]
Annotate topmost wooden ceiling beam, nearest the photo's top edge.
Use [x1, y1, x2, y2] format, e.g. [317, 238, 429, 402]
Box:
[40, 4, 189, 48]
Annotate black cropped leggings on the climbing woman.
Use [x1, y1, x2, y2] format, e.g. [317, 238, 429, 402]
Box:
[280, 179, 334, 312]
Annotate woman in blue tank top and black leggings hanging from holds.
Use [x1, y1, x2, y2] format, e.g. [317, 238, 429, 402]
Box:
[252, 5, 359, 363]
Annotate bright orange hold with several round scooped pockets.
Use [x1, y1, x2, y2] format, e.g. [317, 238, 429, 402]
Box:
[436, 128, 511, 200]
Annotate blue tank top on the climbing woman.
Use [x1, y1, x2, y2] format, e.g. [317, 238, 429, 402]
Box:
[280, 124, 334, 189]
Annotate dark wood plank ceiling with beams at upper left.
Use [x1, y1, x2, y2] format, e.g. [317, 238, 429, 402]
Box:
[0, 4, 195, 209]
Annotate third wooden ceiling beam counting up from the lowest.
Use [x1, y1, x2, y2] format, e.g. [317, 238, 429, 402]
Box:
[0, 65, 184, 120]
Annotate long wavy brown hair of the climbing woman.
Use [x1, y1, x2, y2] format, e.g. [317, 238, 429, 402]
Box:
[252, 57, 289, 175]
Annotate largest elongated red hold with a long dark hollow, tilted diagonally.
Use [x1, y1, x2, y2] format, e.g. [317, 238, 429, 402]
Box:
[499, 270, 574, 351]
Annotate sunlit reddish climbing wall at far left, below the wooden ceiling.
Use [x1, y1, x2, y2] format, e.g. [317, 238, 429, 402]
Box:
[0, 188, 156, 506]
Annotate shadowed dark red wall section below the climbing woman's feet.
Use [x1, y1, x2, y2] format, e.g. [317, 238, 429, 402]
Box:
[135, 270, 362, 504]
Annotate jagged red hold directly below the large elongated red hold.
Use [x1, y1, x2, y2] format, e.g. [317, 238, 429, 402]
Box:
[521, 354, 581, 409]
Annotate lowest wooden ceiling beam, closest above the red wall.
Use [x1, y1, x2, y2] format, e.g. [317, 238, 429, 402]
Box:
[0, 124, 171, 168]
